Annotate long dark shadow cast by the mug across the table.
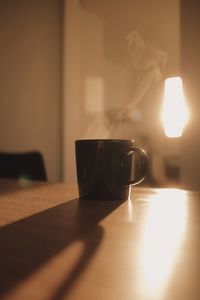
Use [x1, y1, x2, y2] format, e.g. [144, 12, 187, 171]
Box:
[0, 199, 125, 299]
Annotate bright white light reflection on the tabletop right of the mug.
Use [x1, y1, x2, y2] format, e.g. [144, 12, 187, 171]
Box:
[139, 189, 187, 299]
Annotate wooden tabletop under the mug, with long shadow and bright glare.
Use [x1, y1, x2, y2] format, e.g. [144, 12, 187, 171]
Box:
[0, 181, 200, 300]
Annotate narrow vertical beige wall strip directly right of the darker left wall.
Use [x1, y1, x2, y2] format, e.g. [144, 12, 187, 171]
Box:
[62, 0, 82, 182]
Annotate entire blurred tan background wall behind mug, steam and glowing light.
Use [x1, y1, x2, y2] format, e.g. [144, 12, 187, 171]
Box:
[0, 0, 200, 189]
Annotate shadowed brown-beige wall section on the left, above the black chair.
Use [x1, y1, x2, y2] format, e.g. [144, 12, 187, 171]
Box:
[0, 0, 62, 180]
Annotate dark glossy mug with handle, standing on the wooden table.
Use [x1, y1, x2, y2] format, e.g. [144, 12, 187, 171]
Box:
[75, 139, 147, 200]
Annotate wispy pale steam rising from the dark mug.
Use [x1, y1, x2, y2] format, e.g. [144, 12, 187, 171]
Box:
[82, 30, 167, 139]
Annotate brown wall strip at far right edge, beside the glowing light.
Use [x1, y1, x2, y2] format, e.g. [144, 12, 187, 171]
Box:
[181, 0, 200, 190]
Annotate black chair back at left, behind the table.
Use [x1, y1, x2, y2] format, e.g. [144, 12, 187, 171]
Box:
[0, 151, 47, 181]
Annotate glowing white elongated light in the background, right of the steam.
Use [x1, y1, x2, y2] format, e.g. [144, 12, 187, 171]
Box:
[162, 77, 189, 137]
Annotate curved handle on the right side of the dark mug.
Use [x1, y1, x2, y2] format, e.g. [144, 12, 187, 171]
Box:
[126, 147, 148, 185]
